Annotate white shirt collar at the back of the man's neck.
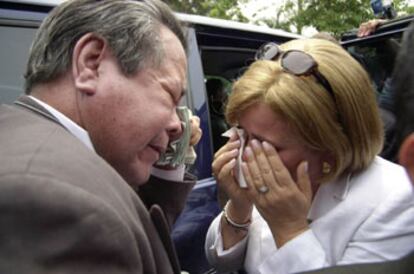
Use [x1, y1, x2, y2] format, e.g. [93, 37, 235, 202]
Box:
[29, 95, 95, 151]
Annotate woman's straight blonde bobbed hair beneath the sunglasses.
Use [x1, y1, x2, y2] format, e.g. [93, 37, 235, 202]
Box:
[226, 39, 383, 182]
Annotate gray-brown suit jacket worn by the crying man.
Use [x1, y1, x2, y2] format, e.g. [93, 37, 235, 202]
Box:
[0, 97, 192, 274]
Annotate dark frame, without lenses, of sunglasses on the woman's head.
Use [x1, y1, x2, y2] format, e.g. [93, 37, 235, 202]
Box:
[255, 42, 336, 104]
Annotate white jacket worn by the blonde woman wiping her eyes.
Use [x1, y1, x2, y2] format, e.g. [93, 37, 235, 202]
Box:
[205, 157, 414, 274]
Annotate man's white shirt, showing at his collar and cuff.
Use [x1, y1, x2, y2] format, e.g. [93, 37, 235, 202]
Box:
[29, 96, 185, 182]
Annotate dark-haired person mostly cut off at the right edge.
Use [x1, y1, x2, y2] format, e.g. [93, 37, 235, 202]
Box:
[300, 20, 414, 274]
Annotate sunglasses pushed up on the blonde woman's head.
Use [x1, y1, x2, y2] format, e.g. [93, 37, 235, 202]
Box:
[255, 43, 336, 103]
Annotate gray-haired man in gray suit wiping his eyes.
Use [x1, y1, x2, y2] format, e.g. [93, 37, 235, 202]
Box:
[0, 0, 201, 274]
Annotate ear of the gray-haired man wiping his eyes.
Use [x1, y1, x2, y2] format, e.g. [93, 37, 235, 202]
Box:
[72, 33, 106, 95]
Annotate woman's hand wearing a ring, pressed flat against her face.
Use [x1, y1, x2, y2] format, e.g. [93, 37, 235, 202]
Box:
[243, 140, 312, 247]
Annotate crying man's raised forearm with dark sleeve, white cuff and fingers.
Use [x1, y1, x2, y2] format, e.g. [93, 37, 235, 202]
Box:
[138, 116, 202, 227]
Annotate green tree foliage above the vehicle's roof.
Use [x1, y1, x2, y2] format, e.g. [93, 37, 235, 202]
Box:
[164, 0, 414, 37]
